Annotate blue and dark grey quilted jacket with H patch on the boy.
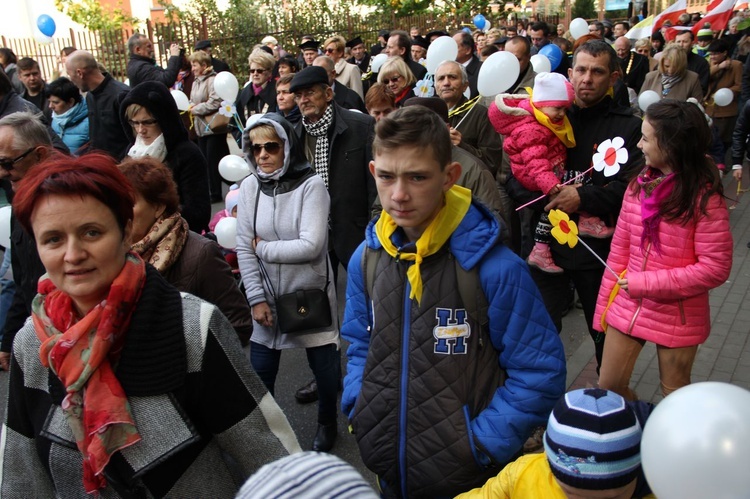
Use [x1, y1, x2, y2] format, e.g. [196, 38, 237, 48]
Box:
[341, 204, 565, 498]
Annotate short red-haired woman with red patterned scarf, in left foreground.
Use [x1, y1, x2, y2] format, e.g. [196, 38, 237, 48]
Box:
[0, 154, 300, 497]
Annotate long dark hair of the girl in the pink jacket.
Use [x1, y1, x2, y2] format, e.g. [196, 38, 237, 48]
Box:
[634, 99, 724, 224]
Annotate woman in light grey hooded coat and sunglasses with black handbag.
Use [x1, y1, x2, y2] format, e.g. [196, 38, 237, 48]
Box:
[237, 114, 340, 452]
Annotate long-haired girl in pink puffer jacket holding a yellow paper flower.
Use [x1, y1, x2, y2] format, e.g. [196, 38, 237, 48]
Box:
[594, 99, 732, 400]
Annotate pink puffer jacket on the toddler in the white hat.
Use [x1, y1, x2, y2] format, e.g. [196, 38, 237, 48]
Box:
[488, 94, 568, 194]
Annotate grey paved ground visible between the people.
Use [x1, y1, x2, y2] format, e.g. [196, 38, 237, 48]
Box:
[0, 173, 750, 490]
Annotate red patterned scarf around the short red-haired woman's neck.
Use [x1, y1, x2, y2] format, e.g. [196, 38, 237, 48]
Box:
[31, 253, 146, 493]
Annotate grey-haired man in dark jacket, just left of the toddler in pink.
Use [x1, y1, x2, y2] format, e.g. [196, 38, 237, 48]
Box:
[435, 61, 503, 175]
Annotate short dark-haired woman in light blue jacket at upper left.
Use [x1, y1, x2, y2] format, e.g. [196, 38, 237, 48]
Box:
[45, 77, 89, 156]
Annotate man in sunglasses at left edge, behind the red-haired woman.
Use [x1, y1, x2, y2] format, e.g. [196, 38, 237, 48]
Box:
[0, 111, 52, 371]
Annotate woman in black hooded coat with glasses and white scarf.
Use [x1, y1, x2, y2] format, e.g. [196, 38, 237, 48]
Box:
[120, 81, 211, 233]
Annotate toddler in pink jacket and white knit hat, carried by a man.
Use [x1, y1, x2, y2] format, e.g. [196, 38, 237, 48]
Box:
[489, 73, 614, 273]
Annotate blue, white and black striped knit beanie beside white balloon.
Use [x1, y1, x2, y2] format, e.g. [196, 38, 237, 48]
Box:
[544, 388, 642, 490]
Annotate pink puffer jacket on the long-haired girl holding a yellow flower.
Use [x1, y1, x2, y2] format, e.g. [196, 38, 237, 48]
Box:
[594, 184, 733, 348]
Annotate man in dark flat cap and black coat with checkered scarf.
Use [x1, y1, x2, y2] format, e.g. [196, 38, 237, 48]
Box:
[289, 66, 376, 430]
